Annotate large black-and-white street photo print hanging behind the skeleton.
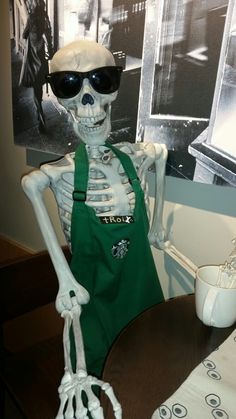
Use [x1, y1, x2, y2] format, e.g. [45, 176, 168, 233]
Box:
[10, 0, 236, 184]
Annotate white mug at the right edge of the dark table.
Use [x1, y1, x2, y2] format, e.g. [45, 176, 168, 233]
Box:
[195, 265, 236, 327]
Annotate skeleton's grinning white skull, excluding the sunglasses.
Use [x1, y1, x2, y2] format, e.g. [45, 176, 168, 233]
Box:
[50, 40, 118, 145]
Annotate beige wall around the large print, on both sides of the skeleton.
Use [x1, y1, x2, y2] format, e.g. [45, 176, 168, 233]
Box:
[0, 0, 236, 297]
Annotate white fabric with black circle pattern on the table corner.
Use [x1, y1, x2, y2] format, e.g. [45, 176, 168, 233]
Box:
[151, 329, 236, 419]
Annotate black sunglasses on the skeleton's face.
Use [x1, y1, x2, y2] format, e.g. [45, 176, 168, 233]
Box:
[46, 66, 123, 99]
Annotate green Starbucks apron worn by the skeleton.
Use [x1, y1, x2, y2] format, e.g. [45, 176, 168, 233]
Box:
[71, 143, 163, 377]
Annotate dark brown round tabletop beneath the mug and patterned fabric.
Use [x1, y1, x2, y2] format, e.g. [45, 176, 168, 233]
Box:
[101, 295, 235, 419]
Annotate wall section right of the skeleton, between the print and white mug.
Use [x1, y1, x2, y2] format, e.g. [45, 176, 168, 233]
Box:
[150, 177, 236, 297]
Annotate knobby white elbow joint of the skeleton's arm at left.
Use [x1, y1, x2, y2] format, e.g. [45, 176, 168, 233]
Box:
[56, 273, 90, 314]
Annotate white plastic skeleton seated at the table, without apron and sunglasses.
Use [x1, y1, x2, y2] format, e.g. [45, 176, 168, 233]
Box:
[22, 41, 195, 419]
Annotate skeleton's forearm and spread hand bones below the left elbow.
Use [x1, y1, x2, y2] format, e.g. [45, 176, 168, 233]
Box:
[56, 297, 122, 419]
